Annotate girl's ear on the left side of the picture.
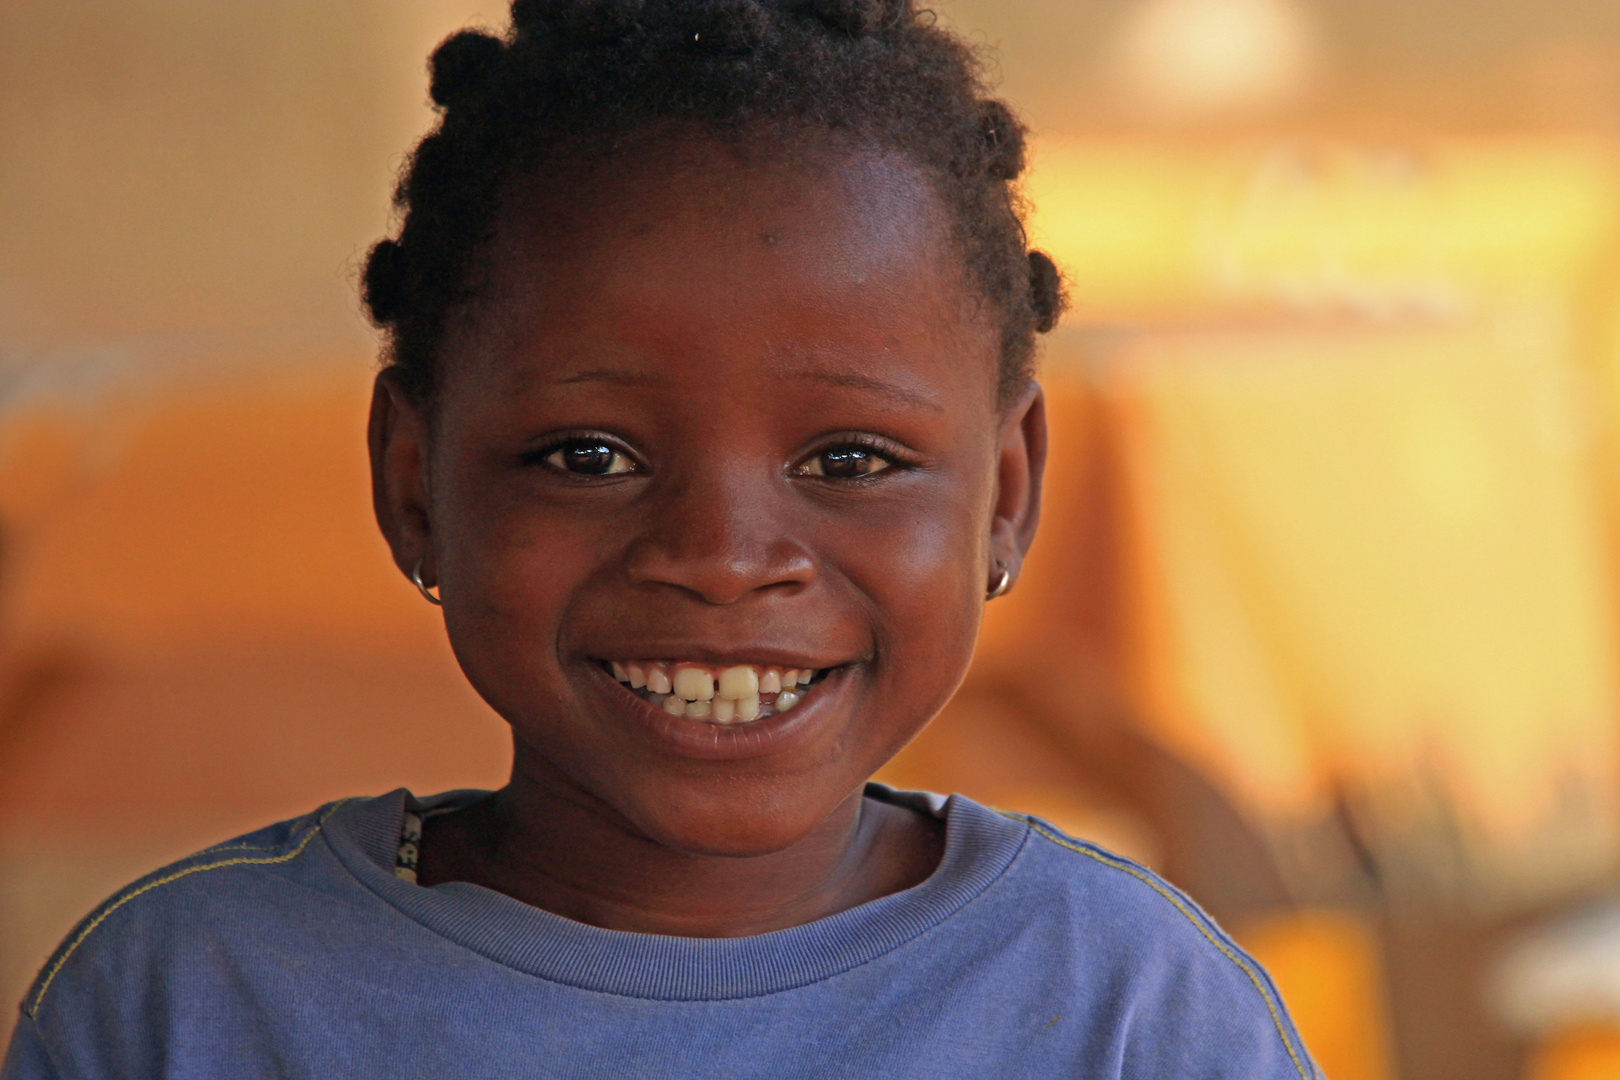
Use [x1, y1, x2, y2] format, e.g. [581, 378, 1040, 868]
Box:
[366, 371, 439, 588]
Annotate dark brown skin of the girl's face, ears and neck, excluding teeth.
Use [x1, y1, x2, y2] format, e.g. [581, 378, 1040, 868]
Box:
[369, 131, 1045, 938]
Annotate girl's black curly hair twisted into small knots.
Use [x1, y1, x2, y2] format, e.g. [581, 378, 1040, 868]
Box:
[363, 0, 1066, 409]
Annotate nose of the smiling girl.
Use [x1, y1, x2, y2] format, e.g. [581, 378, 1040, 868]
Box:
[627, 461, 815, 604]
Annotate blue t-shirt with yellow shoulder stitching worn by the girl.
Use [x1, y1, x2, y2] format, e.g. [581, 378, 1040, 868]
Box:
[0, 785, 1319, 1080]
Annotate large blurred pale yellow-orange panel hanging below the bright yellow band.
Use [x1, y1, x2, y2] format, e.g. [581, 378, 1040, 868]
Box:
[1102, 319, 1620, 910]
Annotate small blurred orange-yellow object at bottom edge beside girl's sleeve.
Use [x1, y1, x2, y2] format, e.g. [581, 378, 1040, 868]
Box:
[1238, 912, 1393, 1080]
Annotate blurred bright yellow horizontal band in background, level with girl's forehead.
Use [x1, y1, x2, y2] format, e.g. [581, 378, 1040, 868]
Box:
[1029, 136, 1620, 324]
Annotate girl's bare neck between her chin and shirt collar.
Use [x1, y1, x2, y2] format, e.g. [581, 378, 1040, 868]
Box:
[418, 751, 943, 938]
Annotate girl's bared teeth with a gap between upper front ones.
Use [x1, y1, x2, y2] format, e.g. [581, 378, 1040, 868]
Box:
[608, 661, 826, 724]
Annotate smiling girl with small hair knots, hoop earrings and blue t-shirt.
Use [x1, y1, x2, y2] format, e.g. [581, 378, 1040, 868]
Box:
[3, 0, 1314, 1080]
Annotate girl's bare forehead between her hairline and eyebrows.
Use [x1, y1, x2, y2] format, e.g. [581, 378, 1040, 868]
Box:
[449, 131, 996, 404]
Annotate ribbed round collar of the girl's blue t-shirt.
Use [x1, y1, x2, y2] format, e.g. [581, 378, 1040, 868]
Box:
[326, 784, 1029, 1001]
